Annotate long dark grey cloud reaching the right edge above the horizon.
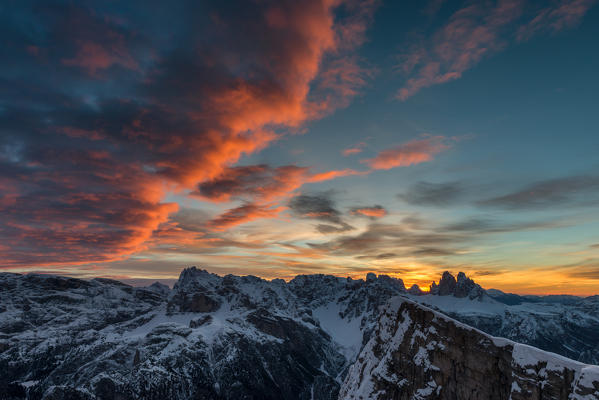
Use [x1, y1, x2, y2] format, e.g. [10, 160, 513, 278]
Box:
[477, 175, 599, 210]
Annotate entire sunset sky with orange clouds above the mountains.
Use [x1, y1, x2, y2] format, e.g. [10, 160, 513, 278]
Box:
[0, 0, 599, 295]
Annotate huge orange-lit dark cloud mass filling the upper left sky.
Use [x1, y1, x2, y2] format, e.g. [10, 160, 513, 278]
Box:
[0, 0, 380, 265]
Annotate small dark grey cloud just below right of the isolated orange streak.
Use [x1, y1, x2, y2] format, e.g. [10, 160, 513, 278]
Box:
[398, 182, 464, 206]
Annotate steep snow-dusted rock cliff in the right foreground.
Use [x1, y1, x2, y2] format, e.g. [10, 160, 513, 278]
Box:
[339, 298, 599, 400]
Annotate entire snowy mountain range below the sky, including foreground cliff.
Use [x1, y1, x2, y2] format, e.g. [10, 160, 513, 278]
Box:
[0, 267, 599, 400]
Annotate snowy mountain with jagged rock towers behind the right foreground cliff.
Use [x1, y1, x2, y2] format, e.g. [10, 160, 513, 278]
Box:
[410, 272, 599, 364]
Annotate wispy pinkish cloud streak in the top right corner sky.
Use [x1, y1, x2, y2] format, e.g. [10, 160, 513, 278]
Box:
[396, 0, 595, 100]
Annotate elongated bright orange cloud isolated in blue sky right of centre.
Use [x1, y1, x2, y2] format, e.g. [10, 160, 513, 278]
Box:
[361, 136, 449, 170]
